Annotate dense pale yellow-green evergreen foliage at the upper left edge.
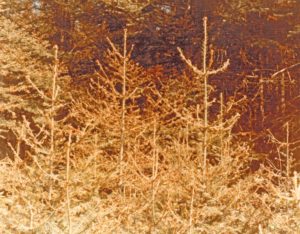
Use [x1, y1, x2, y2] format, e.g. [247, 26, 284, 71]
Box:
[0, 4, 53, 156]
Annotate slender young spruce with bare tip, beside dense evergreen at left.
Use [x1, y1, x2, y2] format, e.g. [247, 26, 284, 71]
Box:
[18, 46, 67, 204]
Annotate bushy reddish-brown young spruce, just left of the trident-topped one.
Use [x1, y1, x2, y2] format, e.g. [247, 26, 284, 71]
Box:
[72, 30, 159, 193]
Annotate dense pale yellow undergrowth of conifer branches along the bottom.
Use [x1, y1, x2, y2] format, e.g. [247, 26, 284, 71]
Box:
[1, 140, 300, 233]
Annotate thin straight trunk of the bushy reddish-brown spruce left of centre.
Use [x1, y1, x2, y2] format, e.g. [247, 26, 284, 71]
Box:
[119, 29, 127, 190]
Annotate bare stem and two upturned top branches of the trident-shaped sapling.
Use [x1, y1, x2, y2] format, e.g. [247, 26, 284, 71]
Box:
[178, 17, 229, 175]
